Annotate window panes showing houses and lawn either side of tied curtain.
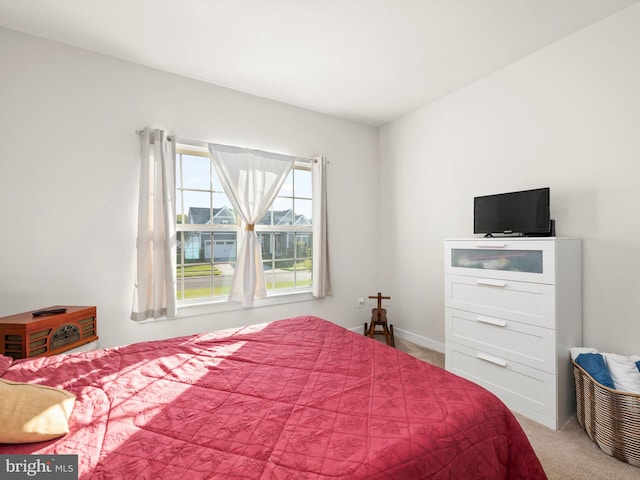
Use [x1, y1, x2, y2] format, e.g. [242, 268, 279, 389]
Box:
[176, 145, 313, 305]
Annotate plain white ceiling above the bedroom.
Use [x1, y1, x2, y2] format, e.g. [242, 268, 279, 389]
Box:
[0, 0, 639, 126]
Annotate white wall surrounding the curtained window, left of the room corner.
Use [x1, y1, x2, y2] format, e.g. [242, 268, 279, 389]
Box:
[0, 29, 378, 346]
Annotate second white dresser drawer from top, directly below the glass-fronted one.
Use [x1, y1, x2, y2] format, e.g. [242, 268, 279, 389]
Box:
[444, 275, 555, 329]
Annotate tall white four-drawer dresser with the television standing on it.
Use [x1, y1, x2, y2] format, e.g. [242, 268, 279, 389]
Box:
[444, 237, 582, 429]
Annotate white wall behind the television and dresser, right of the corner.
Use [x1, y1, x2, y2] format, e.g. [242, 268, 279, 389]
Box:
[379, 5, 640, 353]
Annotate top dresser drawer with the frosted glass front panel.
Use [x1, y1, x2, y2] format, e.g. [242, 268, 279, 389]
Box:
[444, 238, 556, 284]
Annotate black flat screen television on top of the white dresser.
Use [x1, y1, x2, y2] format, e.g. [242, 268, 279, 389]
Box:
[473, 187, 554, 236]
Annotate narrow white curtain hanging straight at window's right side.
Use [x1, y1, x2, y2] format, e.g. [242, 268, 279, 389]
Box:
[312, 157, 333, 298]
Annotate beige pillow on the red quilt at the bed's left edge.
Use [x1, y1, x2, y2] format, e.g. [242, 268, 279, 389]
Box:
[0, 378, 76, 443]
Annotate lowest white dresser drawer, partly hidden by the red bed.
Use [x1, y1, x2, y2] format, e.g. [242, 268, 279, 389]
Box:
[445, 342, 557, 429]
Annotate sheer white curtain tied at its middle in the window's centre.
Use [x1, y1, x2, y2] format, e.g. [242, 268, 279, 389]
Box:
[209, 144, 296, 307]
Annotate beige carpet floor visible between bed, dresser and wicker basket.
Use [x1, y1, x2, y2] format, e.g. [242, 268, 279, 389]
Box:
[396, 338, 640, 480]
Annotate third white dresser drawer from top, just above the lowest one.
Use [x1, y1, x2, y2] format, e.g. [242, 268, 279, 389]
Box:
[445, 308, 556, 374]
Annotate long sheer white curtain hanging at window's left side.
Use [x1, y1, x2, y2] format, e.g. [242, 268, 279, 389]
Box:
[131, 127, 177, 321]
